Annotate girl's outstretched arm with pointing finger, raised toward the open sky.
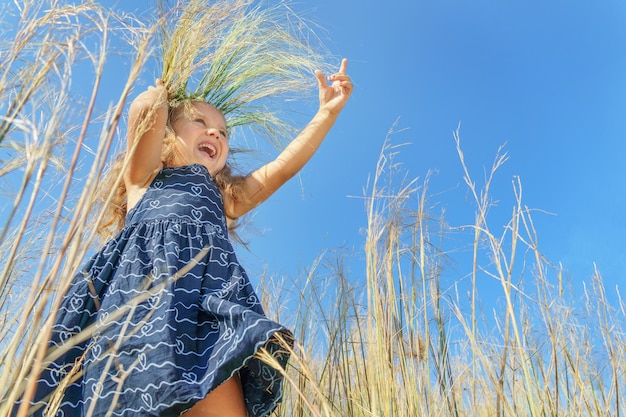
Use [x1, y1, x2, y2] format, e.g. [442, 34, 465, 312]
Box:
[224, 59, 352, 218]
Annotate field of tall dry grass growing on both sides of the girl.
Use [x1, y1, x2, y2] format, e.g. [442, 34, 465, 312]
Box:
[0, 0, 626, 417]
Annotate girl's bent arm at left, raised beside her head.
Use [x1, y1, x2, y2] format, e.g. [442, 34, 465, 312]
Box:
[124, 79, 168, 188]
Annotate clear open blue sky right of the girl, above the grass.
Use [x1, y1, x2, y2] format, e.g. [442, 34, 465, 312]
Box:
[235, 0, 626, 302]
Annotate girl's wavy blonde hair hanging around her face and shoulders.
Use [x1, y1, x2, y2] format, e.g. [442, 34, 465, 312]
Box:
[97, 99, 245, 239]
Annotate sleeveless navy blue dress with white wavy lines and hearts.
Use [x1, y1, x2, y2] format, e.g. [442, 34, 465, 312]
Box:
[19, 165, 291, 417]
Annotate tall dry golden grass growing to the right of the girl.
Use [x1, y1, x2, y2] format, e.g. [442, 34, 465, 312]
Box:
[258, 131, 626, 417]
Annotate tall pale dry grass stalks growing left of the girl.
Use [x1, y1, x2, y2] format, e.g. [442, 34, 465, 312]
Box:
[0, 0, 151, 415]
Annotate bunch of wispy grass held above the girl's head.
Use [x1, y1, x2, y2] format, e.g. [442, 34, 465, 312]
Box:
[161, 0, 327, 147]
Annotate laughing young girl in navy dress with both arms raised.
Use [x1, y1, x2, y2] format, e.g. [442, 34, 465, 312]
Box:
[14, 59, 352, 417]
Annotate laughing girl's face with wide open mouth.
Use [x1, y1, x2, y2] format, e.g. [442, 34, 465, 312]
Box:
[172, 102, 228, 176]
